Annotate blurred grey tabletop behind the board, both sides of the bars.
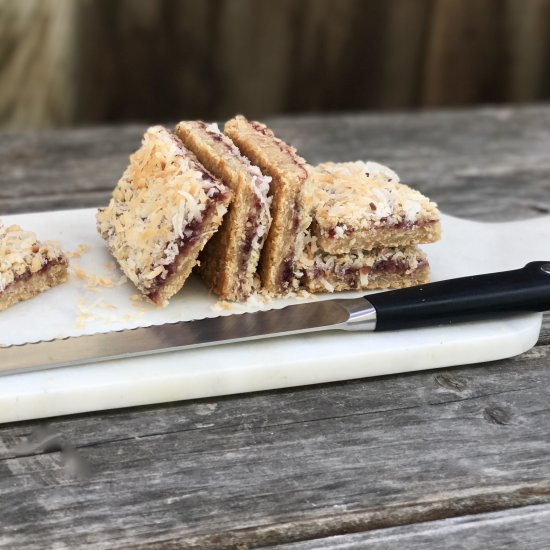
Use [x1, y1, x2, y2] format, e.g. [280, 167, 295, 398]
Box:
[0, 107, 550, 221]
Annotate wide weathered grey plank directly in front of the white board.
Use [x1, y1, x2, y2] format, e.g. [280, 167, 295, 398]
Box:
[0, 346, 550, 549]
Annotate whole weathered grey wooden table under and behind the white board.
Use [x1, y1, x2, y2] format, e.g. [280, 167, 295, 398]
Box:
[0, 107, 550, 550]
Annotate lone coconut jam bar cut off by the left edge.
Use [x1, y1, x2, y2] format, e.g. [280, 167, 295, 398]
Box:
[0, 223, 68, 311]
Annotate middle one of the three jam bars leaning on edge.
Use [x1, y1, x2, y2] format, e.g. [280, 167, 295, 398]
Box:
[176, 121, 271, 301]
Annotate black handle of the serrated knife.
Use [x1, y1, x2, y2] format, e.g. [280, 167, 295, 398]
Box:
[365, 261, 550, 331]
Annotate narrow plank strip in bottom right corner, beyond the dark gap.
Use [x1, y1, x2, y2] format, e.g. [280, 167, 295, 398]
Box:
[264, 504, 550, 550]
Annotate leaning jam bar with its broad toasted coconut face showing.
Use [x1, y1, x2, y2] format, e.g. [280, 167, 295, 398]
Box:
[97, 126, 231, 305]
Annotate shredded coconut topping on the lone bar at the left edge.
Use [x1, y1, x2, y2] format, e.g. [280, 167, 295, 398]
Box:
[0, 222, 66, 292]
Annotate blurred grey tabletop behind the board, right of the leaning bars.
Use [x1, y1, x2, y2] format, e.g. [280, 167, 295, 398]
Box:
[274, 107, 550, 221]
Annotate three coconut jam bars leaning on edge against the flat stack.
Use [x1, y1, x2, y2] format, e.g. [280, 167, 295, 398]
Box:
[97, 116, 310, 305]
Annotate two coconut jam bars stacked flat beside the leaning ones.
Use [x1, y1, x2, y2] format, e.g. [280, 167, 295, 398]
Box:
[302, 162, 440, 292]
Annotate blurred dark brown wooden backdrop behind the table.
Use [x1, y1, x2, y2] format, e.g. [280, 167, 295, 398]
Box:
[0, 0, 550, 130]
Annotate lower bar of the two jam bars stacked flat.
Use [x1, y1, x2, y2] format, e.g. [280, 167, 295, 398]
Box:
[302, 240, 430, 292]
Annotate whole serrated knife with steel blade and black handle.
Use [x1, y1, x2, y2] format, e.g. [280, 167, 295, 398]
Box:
[0, 262, 550, 374]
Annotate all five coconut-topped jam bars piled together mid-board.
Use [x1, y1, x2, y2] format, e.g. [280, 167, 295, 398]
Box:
[97, 116, 439, 304]
